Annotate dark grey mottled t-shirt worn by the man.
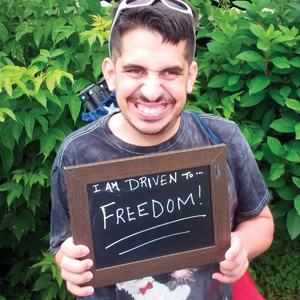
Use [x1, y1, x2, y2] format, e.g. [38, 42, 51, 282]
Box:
[50, 111, 269, 300]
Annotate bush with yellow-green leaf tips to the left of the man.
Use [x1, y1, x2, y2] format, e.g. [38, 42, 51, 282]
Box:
[0, 0, 111, 300]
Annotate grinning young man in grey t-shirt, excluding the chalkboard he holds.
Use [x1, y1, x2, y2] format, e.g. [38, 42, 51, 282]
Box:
[51, 0, 273, 300]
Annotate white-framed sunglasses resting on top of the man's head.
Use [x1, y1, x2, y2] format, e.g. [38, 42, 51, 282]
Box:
[108, 0, 194, 55]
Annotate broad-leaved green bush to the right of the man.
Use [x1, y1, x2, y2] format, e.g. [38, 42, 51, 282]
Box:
[188, 0, 300, 239]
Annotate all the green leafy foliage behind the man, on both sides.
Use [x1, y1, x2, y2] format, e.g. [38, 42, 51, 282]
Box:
[0, 0, 300, 300]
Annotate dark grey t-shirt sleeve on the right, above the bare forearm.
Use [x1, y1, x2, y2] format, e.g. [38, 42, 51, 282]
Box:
[204, 117, 269, 219]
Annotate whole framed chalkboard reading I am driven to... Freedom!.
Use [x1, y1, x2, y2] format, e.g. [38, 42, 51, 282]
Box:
[66, 144, 230, 287]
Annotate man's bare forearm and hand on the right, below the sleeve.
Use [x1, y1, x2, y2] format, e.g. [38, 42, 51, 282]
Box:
[213, 206, 274, 283]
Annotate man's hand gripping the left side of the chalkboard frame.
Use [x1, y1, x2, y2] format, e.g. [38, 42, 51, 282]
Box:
[55, 237, 94, 297]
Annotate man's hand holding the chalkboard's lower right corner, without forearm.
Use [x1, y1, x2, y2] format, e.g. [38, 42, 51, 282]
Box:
[213, 232, 249, 283]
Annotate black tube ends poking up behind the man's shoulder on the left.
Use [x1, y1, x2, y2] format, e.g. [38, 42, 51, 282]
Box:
[79, 77, 111, 111]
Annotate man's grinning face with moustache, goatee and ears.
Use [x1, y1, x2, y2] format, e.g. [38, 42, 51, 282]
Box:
[104, 29, 197, 142]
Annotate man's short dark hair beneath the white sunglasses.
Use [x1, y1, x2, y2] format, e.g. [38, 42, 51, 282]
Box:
[110, 2, 196, 63]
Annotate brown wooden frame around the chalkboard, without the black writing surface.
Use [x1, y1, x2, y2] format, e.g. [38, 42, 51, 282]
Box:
[65, 144, 230, 287]
